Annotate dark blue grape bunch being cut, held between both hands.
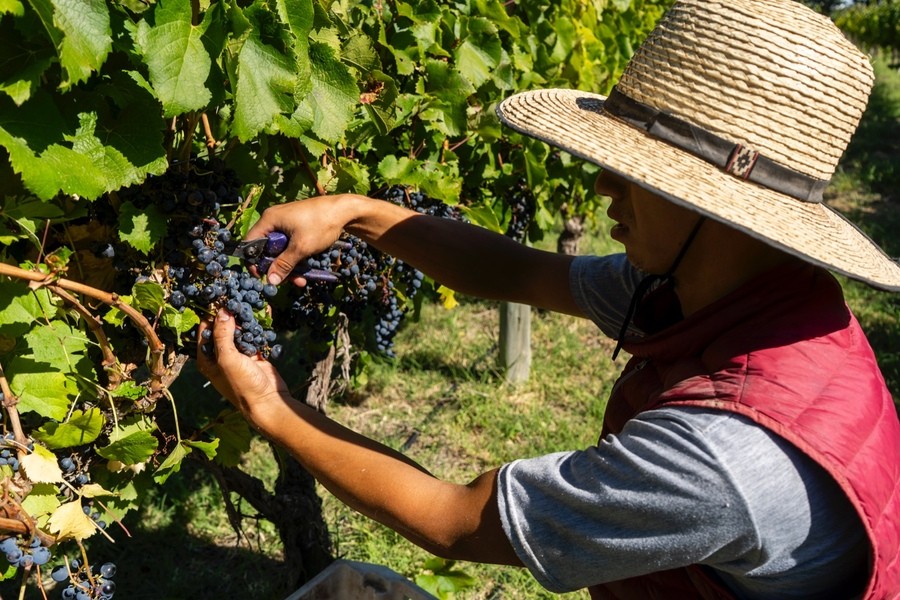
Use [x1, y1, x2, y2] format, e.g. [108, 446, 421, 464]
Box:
[112, 158, 281, 358]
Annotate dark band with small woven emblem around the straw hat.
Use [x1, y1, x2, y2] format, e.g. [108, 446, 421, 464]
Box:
[596, 88, 828, 202]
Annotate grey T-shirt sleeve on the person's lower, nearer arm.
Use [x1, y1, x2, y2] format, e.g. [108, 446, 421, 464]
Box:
[498, 411, 758, 593]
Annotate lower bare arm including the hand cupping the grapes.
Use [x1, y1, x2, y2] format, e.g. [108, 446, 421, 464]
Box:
[197, 311, 521, 565]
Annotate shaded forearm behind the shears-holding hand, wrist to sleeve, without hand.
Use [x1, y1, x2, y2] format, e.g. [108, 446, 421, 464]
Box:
[345, 196, 580, 314]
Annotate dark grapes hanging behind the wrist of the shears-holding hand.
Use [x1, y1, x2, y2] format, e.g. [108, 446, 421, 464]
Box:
[283, 186, 462, 357]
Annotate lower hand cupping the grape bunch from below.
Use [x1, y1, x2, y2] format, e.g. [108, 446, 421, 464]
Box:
[197, 309, 290, 429]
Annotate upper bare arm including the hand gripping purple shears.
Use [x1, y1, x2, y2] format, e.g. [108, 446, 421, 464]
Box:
[247, 194, 583, 316]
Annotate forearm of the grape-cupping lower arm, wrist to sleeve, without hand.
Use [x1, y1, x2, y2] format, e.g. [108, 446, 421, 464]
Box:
[254, 399, 520, 564]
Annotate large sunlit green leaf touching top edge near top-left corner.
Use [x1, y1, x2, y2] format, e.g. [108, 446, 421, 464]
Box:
[29, 0, 112, 89]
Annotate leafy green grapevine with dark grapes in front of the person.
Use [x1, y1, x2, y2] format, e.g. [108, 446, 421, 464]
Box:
[0, 0, 669, 600]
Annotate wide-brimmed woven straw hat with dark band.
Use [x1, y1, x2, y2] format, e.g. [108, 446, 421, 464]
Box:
[497, 0, 900, 291]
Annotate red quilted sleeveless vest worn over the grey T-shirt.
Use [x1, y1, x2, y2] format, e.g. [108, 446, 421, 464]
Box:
[590, 263, 900, 600]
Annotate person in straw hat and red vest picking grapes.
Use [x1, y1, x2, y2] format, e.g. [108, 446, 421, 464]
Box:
[198, 0, 900, 599]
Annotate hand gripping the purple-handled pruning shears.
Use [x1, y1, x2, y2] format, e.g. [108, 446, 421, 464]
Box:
[246, 194, 366, 285]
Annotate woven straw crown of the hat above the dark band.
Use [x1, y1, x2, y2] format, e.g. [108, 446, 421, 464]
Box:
[616, 0, 874, 180]
